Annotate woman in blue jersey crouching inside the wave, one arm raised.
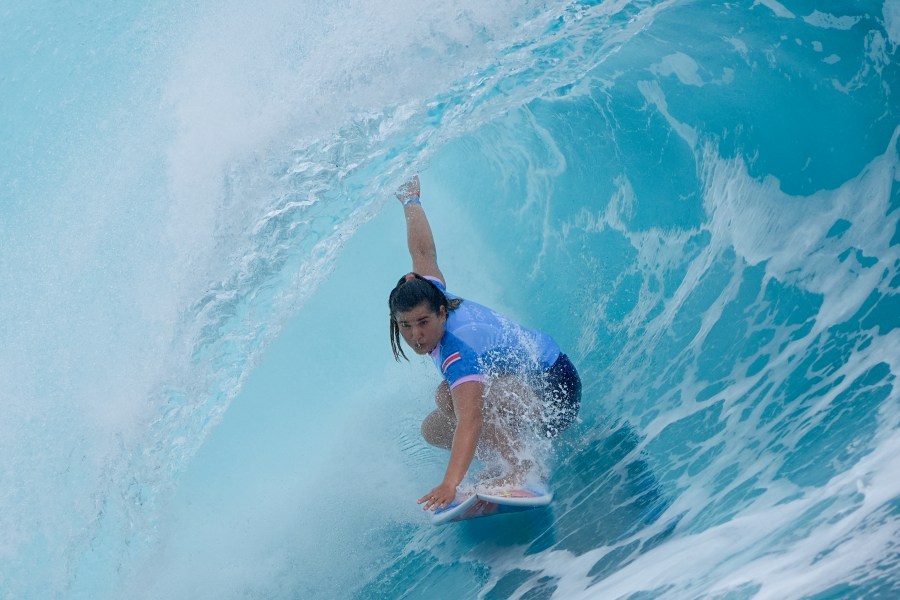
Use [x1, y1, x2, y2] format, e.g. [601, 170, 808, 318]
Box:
[388, 176, 581, 510]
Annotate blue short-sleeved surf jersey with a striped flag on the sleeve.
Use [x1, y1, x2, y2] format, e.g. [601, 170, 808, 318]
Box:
[427, 277, 560, 389]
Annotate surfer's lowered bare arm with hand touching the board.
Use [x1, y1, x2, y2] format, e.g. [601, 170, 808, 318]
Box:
[419, 381, 484, 510]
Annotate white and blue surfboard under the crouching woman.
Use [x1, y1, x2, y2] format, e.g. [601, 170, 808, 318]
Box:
[431, 485, 553, 525]
